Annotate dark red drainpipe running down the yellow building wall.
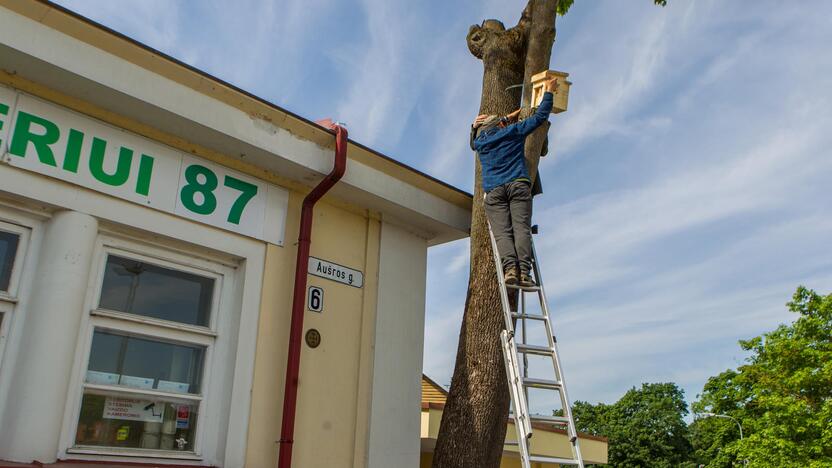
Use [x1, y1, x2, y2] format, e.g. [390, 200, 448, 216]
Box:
[277, 124, 347, 468]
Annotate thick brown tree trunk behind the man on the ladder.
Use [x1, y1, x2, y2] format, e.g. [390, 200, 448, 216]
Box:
[433, 0, 557, 468]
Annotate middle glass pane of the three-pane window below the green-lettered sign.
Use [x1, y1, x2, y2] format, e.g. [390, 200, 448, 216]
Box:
[86, 330, 205, 393]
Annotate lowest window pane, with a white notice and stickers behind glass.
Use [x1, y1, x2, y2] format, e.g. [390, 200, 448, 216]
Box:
[75, 393, 198, 452]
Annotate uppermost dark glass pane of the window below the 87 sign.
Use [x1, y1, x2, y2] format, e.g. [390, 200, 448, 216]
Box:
[100, 255, 214, 327]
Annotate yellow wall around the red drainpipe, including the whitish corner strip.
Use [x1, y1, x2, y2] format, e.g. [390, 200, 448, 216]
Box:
[246, 205, 427, 468]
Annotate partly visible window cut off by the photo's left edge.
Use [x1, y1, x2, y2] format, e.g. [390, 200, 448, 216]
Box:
[0, 221, 30, 372]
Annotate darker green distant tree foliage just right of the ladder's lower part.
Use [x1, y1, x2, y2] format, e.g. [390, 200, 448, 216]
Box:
[574, 383, 692, 468]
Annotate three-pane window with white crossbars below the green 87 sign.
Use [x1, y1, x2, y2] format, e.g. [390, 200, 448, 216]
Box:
[74, 245, 223, 456]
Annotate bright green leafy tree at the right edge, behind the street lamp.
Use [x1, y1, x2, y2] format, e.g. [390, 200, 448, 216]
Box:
[691, 287, 832, 468]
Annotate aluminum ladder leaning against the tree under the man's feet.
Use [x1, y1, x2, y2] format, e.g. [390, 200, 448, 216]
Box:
[488, 223, 584, 468]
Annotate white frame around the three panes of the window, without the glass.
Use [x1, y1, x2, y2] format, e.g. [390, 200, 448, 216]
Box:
[62, 233, 237, 461]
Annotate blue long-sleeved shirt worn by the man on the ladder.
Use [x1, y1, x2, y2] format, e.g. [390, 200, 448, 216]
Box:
[474, 93, 552, 192]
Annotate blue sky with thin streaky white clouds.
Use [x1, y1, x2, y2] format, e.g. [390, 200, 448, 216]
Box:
[59, 0, 832, 410]
